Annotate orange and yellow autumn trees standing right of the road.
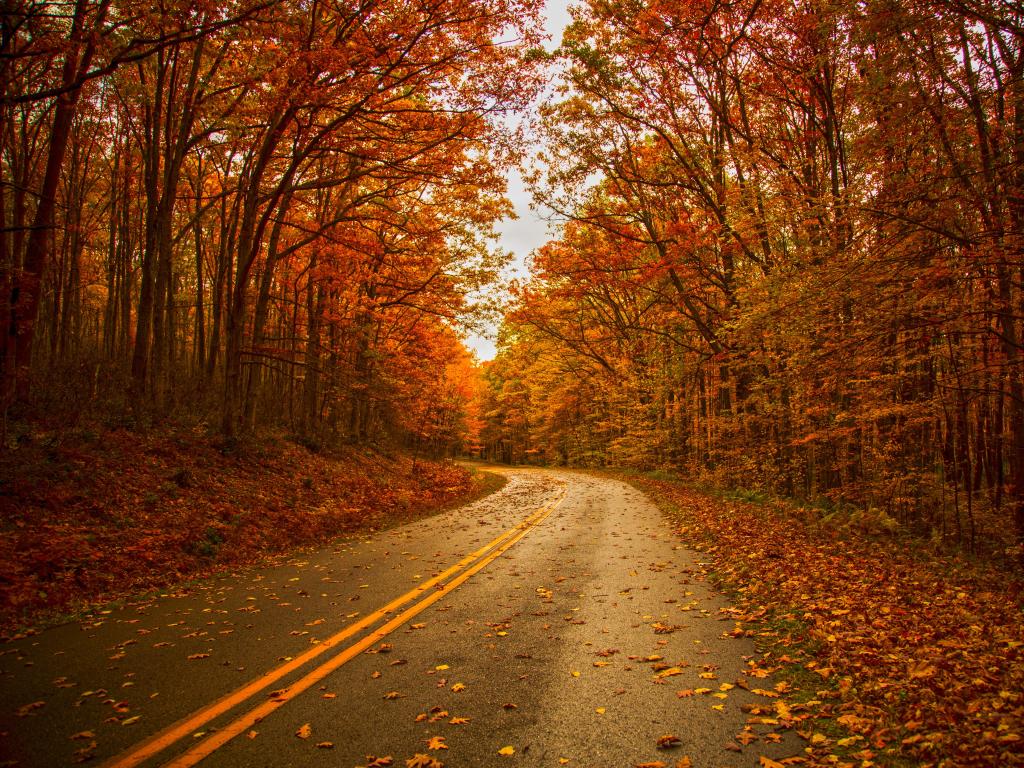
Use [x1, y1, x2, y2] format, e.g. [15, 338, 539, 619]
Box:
[481, 0, 1024, 554]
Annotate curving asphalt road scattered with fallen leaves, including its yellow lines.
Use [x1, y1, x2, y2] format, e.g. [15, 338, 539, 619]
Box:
[0, 469, 801, 768]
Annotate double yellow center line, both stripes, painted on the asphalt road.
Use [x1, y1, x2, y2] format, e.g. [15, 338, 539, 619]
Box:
[103, 490, 565, 768]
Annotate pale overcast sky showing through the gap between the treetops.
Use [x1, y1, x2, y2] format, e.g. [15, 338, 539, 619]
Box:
[466, 0, 569, 360]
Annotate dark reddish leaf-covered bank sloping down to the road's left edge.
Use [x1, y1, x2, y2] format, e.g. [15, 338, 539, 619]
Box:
[0, 428, 483, 635]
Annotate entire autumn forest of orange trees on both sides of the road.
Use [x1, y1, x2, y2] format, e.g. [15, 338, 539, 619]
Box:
[0, 0, 1024, 555]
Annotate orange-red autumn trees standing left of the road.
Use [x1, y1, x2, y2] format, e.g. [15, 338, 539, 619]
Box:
[0, 0, 540, 451]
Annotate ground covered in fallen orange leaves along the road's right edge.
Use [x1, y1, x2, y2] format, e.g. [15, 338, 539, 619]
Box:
[631, 477, 1024, 768]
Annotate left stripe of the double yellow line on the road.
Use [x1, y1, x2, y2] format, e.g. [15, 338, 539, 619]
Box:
[103, 493, 564, 768]
